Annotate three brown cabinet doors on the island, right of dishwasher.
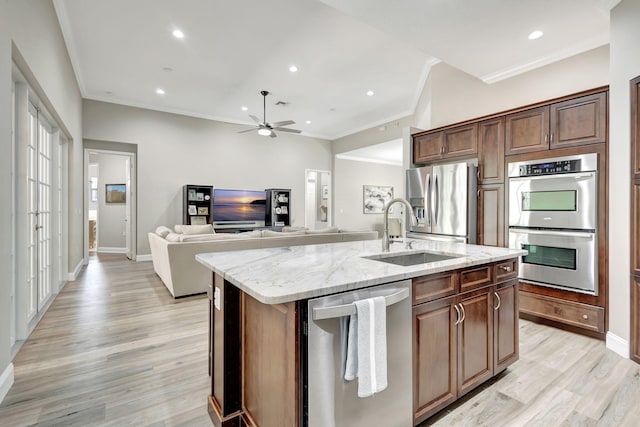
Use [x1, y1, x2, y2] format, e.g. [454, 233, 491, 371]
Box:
[413, 270, 519, 424]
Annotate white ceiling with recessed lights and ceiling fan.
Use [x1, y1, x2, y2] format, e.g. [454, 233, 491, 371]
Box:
[54, 0, 619, 139]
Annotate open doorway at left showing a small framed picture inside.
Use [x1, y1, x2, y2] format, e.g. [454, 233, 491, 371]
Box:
[84, 148, 136, 263]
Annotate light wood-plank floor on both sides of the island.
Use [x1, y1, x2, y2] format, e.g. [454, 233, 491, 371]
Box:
[0, 256, 640, 427]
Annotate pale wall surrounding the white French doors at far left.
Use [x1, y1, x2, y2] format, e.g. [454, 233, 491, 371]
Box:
[0, 0, 83, 397]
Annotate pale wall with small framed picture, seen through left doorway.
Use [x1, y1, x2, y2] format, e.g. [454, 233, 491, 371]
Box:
[91, 153, 127, 252]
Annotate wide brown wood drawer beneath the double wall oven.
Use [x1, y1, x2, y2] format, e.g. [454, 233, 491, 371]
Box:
[520, 291, 604, 332]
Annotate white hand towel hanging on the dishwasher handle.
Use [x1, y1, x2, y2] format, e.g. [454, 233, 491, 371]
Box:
[345, 297, 387, 397]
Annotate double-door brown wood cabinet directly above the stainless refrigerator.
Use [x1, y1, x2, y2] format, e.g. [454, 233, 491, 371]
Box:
[413, 123, 478, 164]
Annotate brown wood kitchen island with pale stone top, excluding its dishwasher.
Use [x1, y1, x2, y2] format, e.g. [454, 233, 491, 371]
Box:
[196, 240, 524, 427]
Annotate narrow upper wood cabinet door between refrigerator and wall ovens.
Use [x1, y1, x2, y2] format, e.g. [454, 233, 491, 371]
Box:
[478, 117, 505, 185]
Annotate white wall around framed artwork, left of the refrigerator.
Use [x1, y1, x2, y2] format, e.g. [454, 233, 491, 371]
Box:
[333, 159, 404, 233]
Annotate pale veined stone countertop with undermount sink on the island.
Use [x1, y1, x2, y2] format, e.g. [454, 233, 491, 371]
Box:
[196, 239, 526, 304]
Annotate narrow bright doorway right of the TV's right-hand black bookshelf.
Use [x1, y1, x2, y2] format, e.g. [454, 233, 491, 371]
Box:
[304, 169, 332, 230]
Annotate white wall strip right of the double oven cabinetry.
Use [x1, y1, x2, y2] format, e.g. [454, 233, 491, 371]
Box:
[607, 0, 640, 352]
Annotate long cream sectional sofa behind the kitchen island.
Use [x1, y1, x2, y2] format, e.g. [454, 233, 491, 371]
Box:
[149, 227, 378, 298]
